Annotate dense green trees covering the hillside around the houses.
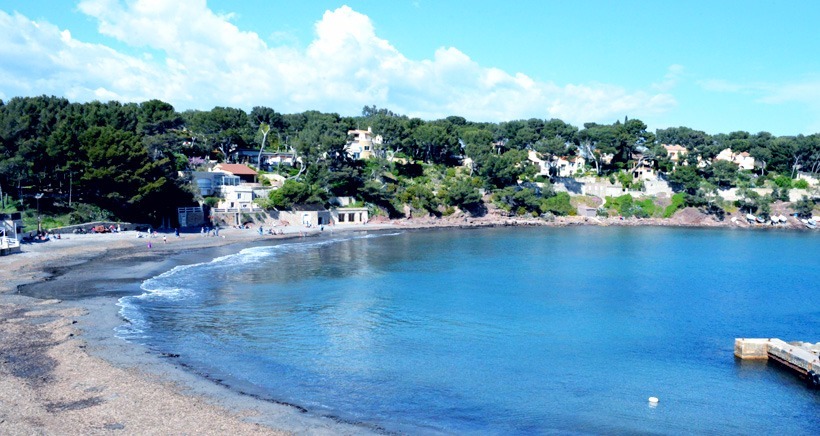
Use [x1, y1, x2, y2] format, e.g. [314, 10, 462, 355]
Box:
[0, 96, 820, 224]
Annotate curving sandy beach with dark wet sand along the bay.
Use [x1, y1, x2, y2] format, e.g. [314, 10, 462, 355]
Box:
[0, 217, 812, 434]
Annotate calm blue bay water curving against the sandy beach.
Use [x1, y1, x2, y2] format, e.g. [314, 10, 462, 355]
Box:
[119, 228, 820, 434]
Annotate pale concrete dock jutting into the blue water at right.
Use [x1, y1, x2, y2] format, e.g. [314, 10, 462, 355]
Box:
[735, 338, 820, 389]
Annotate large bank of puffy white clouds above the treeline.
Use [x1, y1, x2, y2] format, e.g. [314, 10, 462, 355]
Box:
[0, 0, 683, 123]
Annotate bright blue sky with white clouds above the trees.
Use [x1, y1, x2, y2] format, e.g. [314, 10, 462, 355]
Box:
[0, 0, 820, 135]
